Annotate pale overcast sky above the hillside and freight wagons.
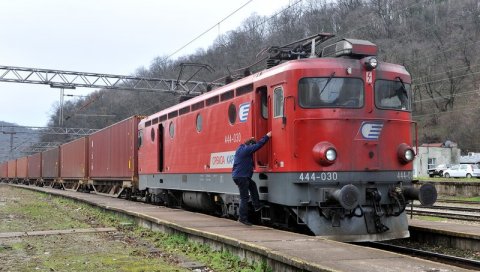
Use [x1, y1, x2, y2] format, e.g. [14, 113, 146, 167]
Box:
[0, 0, 290, 126]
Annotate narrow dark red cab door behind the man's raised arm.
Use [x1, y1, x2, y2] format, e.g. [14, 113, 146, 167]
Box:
[253, 86, 270, 168]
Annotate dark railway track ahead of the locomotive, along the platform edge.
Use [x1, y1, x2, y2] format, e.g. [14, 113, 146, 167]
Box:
[360, 242, 480, 271]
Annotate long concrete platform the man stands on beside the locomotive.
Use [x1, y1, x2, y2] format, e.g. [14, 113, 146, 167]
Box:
[10, 185, 469, 272]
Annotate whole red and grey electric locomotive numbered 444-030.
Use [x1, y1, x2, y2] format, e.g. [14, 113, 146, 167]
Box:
[139, 34, 436, 241]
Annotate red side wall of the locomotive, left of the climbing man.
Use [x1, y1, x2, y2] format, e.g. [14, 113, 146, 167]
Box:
[139, 78, 254, 175]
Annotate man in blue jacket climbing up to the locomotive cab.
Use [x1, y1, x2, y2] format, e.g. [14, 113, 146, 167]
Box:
[232, 131, 272, 226]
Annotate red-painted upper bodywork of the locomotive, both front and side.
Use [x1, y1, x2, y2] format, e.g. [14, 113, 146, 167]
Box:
[139, 58, 412, 177]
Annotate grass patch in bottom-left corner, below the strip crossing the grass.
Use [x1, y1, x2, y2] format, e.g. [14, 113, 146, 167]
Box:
[7, 234, 188, 272]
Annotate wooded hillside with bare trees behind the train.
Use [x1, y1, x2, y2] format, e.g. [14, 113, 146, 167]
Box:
[42, 0, 480, 152]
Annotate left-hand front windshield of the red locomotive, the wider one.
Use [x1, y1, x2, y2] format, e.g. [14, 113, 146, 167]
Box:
[298, 77, 364, 108]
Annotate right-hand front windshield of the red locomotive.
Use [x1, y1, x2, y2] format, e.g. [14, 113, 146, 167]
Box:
[375, 80, 412, 111]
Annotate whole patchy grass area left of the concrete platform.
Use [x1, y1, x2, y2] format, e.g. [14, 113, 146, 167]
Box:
[0, 187, 273, 272]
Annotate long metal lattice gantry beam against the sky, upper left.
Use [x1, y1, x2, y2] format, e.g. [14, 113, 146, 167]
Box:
[0, 66, 222, 94]
